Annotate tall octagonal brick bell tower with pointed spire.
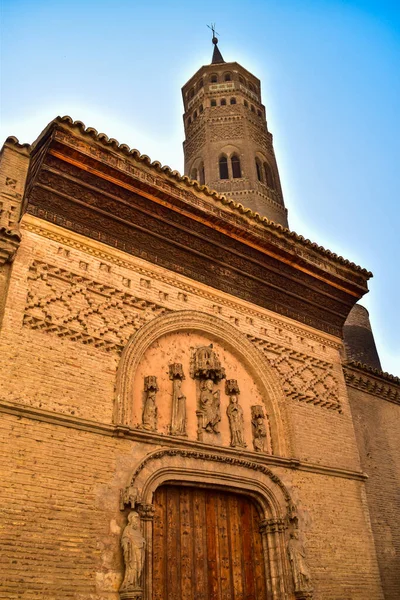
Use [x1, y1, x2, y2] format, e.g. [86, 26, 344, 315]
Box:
[182, 35, 288, 227]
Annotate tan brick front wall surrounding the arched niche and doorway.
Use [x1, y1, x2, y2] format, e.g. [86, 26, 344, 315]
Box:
[0, 218, 388, 600]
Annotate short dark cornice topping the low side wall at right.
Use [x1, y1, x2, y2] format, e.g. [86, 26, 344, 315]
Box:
[343, 362, 400, 404]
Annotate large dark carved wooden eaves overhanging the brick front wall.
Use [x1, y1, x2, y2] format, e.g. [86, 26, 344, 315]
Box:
[21, 118, 371, 337]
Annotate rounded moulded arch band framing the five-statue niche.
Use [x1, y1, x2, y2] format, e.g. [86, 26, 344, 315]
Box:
[114, 311, 292, 456]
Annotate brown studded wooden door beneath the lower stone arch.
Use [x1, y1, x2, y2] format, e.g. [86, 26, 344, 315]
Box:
[152, 485, 267, 600]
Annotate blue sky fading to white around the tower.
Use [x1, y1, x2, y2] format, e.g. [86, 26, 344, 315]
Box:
[0, 0, 400, 375]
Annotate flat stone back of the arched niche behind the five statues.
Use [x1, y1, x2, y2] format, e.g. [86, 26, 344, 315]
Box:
[132, 331, 273, 454]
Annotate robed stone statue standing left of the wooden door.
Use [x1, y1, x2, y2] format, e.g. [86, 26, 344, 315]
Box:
[119, 511, 145, 598]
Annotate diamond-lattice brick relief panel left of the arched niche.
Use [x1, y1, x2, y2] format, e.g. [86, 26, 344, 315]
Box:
[24, 260, 168, 353]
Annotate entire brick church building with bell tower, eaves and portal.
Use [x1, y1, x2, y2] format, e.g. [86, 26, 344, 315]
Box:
[0, 40, 400, 600]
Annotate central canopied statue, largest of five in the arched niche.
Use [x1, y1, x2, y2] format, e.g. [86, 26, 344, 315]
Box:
[190, 344, 226, 441]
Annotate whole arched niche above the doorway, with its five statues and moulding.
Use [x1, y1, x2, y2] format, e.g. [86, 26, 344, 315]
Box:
[114, 311, 292, 457]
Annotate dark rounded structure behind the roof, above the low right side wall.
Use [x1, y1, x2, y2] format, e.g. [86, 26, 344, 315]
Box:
[343, 304, 381, 371]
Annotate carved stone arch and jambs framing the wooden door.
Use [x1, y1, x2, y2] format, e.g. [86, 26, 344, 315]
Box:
[121, 448, 304, 600]
